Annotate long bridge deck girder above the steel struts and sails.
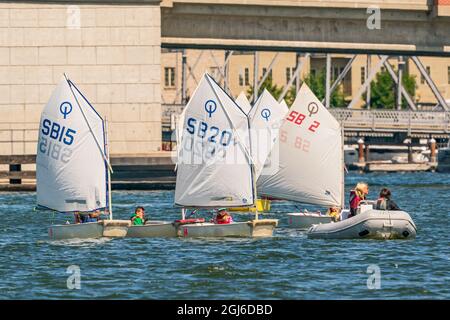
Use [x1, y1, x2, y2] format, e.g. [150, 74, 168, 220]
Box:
[161, 0, 450, 56]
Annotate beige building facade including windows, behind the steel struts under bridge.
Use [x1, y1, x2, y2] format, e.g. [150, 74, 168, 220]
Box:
[161, 49, 450, 107]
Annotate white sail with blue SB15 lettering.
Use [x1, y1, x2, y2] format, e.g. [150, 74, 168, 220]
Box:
[36, 79, 108, 212]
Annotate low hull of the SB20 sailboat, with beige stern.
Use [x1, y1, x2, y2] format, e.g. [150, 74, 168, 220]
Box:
[177, 219, 278, 238]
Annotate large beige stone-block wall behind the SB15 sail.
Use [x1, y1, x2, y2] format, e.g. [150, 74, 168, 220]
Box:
[0, 1, 161, 154]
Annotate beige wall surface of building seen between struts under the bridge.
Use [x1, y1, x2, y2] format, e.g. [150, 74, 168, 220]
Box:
[161, 50, 450, 107]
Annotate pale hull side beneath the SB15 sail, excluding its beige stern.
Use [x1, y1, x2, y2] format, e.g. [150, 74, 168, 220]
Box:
[48, 221, 103, 240]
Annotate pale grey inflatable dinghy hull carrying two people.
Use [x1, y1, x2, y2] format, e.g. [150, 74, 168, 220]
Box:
[307, 209, 417, 240]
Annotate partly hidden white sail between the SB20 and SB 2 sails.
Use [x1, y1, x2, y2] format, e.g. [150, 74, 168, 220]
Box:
[248, 89, 288, 177]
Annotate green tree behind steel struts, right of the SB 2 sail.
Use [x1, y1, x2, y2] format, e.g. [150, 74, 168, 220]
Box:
[364, 70, 417, 109]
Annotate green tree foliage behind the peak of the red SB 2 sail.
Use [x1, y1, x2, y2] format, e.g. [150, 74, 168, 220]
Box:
[286, 69, 345, 108]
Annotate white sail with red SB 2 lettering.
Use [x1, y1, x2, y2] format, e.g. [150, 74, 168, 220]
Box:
[258, 84, 344, 206]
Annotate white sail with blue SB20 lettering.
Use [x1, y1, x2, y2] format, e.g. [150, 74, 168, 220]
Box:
[175, 74, 255, 207]
